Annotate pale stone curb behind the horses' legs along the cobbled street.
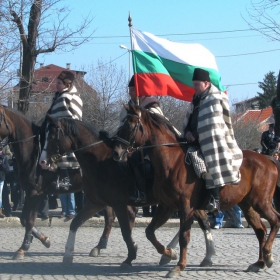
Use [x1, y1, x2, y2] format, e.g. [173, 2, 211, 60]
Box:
[0, 217, 270, 229]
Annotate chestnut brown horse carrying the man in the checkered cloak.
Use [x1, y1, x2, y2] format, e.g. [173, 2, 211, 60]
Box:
[114, 104, 280, 277]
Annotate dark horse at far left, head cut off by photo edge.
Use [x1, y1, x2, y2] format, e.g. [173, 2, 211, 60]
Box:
[0, 106, 135, 259]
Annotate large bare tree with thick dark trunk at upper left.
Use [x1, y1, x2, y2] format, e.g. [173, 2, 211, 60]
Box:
[0, 0, 95, 113]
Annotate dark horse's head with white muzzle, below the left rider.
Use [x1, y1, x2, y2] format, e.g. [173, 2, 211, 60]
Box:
[39, 115, 72, 170]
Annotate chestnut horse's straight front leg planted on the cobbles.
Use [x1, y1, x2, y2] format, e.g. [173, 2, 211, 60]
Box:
[166, 207, 194, 278]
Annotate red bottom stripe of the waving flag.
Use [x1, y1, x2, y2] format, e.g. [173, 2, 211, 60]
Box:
[134, 73, 194, 101]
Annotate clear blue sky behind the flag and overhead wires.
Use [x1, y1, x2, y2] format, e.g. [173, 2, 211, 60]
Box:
[36, 0, 280, 104]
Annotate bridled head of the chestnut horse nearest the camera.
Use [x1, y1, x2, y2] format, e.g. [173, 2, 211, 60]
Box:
[113, 102, 146, 161]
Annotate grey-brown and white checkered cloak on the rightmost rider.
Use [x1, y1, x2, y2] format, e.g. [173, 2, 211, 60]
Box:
[184, 85, 243, 187]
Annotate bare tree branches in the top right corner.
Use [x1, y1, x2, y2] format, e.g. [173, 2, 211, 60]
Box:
[243, 0, 280, 41]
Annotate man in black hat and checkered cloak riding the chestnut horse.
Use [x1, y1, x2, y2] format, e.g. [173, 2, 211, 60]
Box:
[183, 68, 243, 211]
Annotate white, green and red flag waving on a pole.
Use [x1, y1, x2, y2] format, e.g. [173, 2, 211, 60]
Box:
[130, 27, 225, 101]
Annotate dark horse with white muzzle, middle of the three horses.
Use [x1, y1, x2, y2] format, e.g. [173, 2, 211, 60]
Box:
[40, 117, 214, 267]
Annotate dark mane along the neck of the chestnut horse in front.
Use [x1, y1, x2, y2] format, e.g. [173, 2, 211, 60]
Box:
[139, 107, 180, 141]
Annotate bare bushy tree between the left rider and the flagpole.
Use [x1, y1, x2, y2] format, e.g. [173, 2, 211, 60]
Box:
[82, 60, 128, 132]
